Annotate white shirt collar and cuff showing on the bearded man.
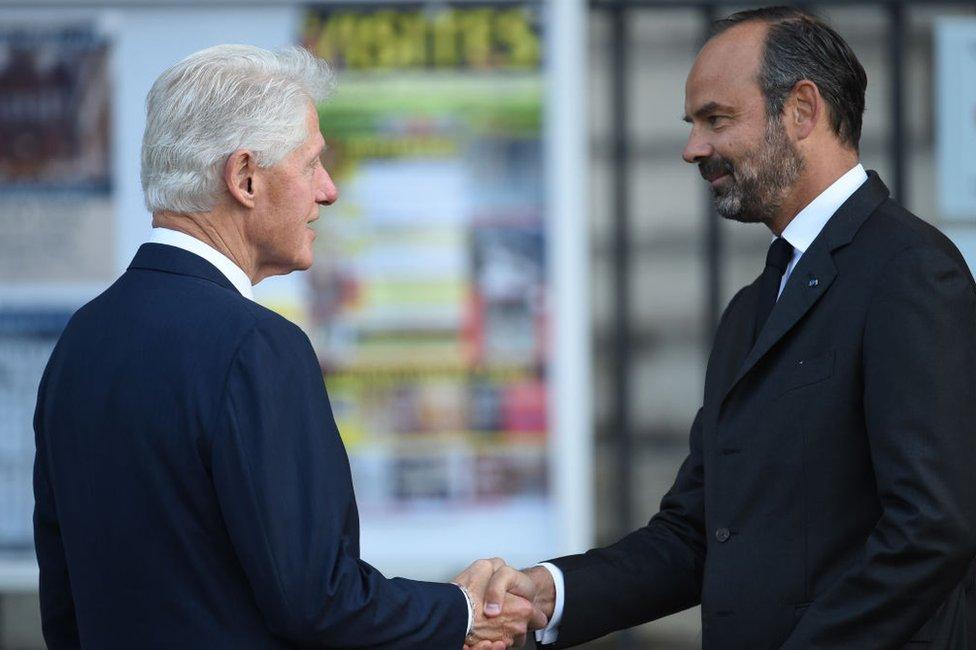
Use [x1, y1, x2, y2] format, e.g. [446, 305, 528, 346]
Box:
[535, 164, 868, 643]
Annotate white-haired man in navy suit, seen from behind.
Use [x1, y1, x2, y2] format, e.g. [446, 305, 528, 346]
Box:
[34, 45, 544, 650]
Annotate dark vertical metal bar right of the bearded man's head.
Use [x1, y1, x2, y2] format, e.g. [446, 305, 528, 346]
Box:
[888, 2, 910, 206]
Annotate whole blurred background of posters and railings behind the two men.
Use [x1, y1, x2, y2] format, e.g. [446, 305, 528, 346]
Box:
[0, 0, 976, 650]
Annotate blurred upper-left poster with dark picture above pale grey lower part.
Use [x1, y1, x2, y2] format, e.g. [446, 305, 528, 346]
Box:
[0, 21, 115, 285]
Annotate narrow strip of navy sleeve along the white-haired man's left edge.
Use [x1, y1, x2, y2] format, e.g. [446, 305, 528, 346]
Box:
[34, 362, 81, 650]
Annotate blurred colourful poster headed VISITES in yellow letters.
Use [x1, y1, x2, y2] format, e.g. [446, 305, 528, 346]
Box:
[300, 3, 555, 565]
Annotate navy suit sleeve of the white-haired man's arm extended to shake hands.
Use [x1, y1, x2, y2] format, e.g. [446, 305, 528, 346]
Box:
[211, 319, 468, 649]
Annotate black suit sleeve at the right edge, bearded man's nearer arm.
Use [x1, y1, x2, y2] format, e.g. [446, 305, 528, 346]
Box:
[783, 248, 976, 650]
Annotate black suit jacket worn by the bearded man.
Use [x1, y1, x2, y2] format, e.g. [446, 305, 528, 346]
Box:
[540, 172, 976, 650]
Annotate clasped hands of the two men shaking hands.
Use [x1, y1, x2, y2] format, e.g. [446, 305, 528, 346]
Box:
[451, 558, 556, 650]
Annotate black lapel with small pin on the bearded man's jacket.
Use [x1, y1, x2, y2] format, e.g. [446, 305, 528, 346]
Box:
[719, 171, 889, 404]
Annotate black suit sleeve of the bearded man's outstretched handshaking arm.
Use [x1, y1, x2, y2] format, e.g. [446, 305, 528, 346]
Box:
[545, 410, 705, 648]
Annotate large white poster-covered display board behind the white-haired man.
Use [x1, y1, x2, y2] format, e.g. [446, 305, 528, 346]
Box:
[0, 0, 593, 589]
